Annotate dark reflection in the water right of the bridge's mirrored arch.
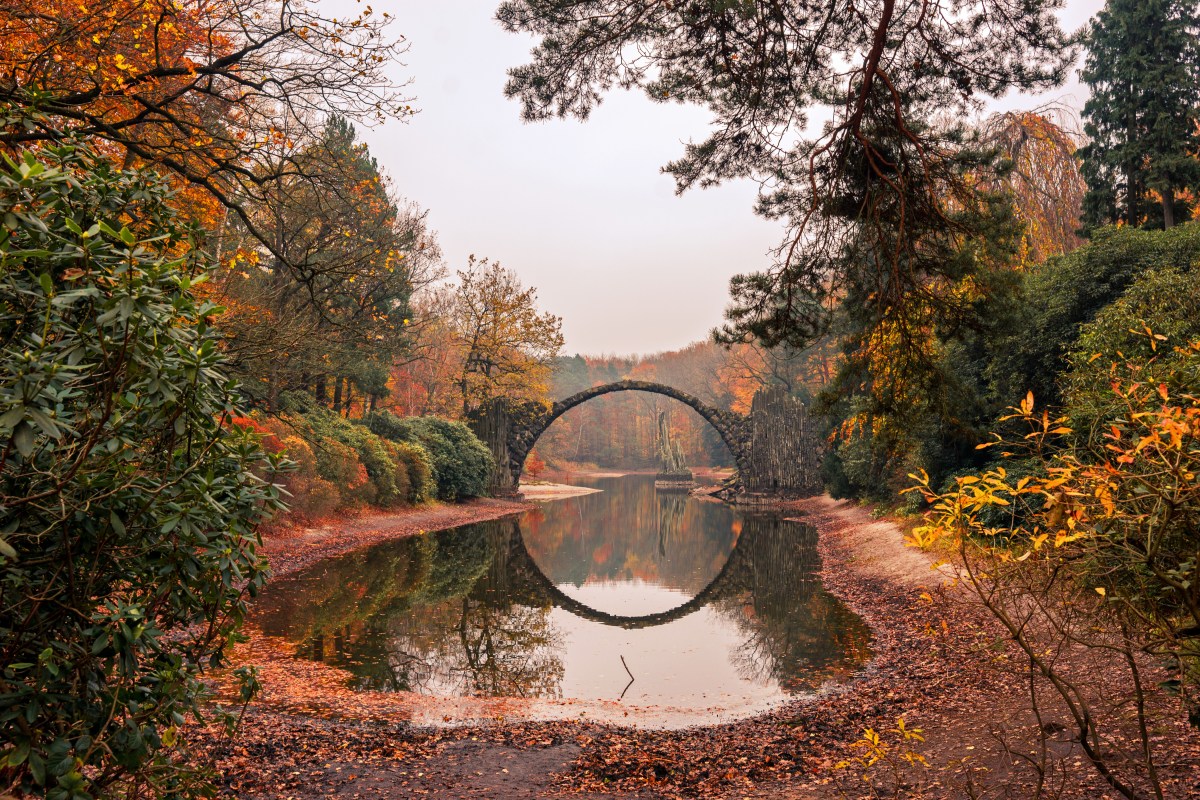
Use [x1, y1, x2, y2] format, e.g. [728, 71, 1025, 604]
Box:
[718, 516, 870, 690]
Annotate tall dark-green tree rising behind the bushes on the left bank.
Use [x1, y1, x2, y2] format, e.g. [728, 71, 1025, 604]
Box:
[220, 115, 440, 414]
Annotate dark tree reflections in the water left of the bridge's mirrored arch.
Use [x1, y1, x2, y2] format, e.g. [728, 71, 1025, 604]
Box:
[257, 521, 563, 697]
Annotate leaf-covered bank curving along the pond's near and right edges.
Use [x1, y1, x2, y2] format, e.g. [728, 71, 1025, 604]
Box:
[192, 498, 1200, 800]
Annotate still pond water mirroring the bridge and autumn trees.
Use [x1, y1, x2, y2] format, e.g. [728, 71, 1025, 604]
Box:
[253, 475, 870, 727]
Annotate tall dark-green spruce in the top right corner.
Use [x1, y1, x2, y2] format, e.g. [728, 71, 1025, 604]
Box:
[1081, 0, 1200, 228]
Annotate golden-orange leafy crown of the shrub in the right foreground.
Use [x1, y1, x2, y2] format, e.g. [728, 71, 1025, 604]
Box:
[913, 332, 1200, 715]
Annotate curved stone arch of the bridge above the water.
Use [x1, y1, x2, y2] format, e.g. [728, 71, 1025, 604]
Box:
[506, 380, 750, 488]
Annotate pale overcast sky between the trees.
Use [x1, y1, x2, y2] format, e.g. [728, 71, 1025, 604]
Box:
[352, 0, 1103, 354]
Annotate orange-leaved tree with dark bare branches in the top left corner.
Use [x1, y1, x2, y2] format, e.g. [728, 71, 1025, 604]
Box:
[0, 0, 410, 251]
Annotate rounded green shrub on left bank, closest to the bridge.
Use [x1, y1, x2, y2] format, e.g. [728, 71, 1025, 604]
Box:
[366, 411, 496, 500]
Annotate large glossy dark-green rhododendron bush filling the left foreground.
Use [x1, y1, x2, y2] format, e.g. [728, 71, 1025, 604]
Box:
[0, 146, 281, 800]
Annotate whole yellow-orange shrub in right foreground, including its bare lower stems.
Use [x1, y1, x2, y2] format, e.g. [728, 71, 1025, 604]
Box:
[910, 329, 1200, 796]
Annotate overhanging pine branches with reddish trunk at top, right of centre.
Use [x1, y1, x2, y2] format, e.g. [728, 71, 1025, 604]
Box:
[497, 0, 1073, 343]
